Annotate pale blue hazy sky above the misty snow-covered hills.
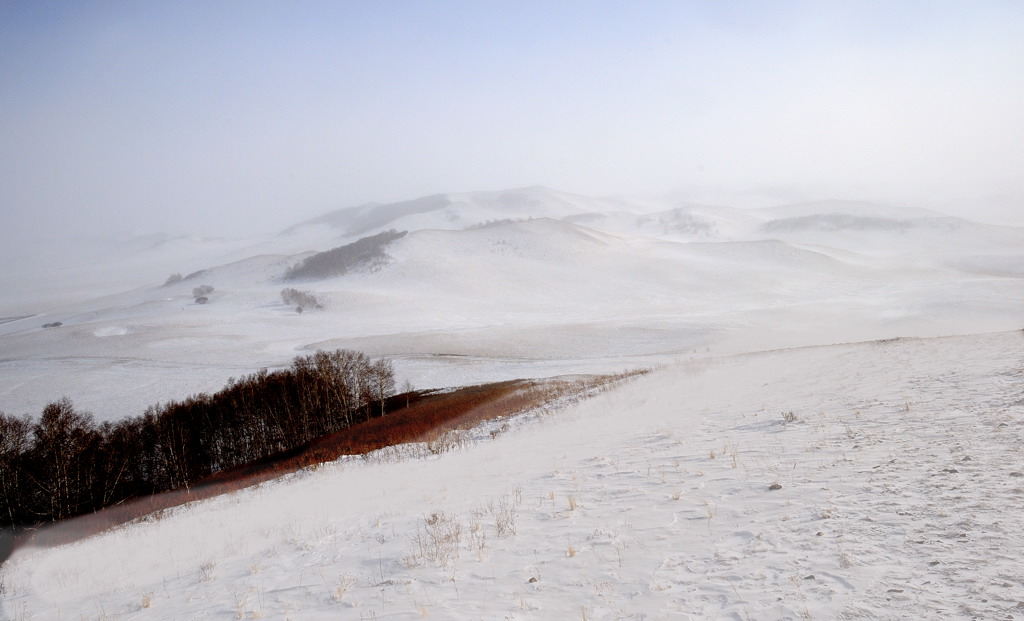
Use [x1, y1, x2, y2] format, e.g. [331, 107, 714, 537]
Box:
[0, 0, 1024, 251]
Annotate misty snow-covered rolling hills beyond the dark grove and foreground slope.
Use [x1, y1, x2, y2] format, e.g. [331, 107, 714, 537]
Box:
[0, 187, 1024, 418]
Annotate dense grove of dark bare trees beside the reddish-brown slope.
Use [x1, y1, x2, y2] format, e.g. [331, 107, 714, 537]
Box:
[0, 349, 394, 527]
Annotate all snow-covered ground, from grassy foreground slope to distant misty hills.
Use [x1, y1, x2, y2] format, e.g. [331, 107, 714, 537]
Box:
[0, 188, 1024, 620]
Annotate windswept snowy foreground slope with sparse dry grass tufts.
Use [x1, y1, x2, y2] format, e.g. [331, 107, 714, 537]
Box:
[6, 331, 1024, 620]
